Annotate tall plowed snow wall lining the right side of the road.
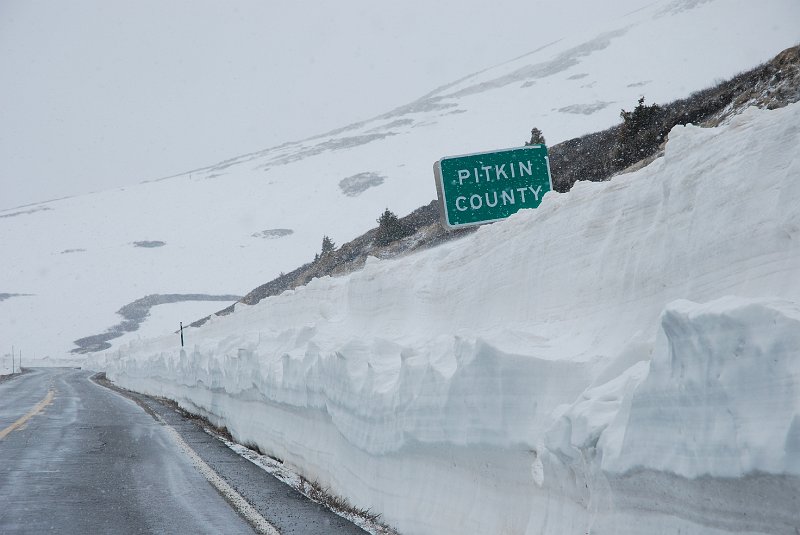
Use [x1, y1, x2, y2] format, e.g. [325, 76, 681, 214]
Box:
[90, 105, 800, 535]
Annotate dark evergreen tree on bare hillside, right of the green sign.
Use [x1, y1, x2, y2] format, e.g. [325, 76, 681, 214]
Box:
[612, 97, 666, 169]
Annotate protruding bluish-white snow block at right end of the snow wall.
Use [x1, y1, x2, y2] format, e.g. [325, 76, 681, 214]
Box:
[603, 297, 800, 477]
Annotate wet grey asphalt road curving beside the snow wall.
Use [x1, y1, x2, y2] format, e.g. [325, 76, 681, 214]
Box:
[0, 368, 365, 535]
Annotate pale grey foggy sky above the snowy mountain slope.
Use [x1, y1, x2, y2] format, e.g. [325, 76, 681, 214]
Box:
[0, 0, 650, 209]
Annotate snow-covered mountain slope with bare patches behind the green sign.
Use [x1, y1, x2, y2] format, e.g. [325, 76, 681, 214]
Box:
[0, 0, 800, 358]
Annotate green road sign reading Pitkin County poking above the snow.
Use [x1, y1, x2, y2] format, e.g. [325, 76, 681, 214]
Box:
[433, 145, 553, 228]
